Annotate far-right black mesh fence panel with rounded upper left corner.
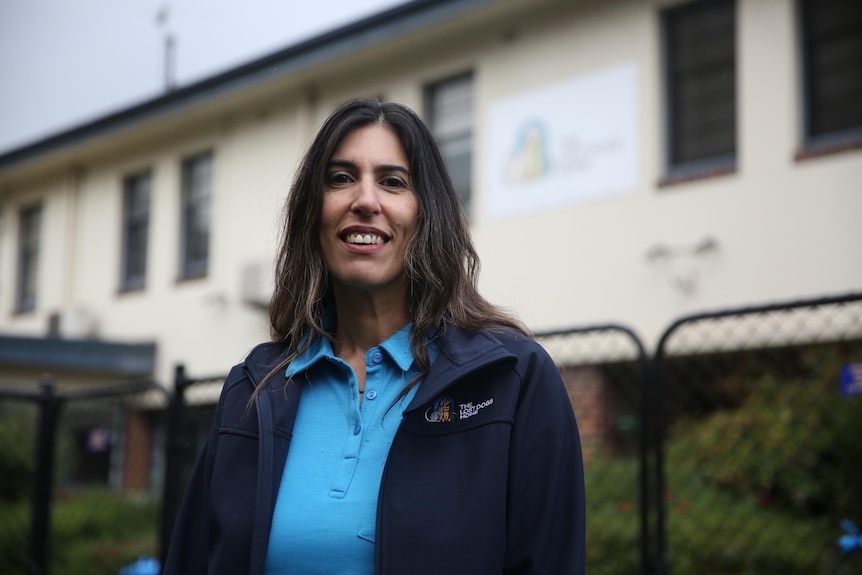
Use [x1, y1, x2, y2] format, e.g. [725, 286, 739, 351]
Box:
[654, 294, 862, 575]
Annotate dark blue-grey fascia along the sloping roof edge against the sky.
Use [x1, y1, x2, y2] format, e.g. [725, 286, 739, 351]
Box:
[0, 0, 494, 178]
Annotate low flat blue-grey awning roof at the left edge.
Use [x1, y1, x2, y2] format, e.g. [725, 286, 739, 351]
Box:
[0, 336, 156, 377]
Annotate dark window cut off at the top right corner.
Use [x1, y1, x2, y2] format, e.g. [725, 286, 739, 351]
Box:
[800, 0, 862, 151]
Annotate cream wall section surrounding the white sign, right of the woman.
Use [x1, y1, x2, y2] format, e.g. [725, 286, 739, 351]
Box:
[475, 0, 862, 345]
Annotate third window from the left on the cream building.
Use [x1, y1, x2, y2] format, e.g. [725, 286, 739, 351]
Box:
[180, 152, 212, 279]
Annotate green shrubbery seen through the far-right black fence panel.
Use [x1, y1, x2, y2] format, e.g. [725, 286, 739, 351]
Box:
[666, 346, 862, 575]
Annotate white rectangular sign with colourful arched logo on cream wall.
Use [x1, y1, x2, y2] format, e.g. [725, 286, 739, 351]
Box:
[488, 64, 638, 217]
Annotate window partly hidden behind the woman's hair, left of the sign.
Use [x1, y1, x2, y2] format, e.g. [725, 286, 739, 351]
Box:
[425, 74, 473, 208]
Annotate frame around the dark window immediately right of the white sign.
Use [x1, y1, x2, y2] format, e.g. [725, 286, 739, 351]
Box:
[659, 0, 739, 185]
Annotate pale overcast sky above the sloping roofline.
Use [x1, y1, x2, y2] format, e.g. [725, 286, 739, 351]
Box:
[0, 0, 405, 154]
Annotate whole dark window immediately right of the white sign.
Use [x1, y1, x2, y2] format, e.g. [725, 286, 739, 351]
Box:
[663, 0, 736, 177]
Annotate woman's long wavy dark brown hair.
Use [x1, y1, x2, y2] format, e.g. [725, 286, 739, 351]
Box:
[255, 99, 529, 400]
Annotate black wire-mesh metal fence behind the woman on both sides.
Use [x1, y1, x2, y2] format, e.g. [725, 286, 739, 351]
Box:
[0, 294, 862, 575]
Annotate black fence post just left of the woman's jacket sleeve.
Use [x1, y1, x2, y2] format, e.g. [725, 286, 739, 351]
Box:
[159, 364, 191, 565]
